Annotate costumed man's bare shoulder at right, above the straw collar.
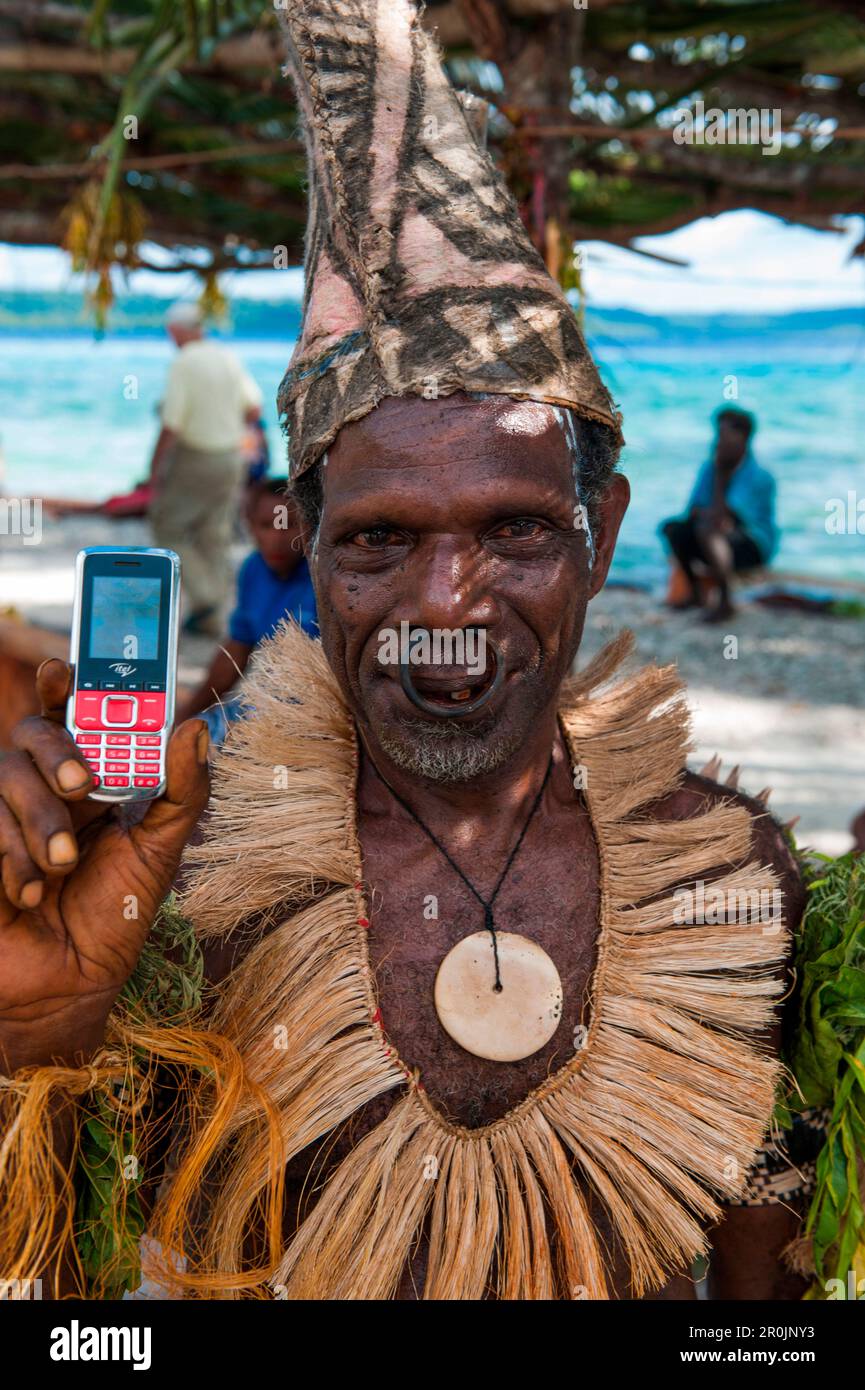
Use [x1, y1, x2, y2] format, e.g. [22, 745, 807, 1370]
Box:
[645, 770, 805, 930]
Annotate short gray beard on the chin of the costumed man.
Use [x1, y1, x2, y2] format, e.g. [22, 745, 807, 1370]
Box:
[378, 719, 522, 783]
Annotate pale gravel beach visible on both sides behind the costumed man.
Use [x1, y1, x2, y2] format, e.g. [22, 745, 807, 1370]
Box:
[0, 517, 865, 853]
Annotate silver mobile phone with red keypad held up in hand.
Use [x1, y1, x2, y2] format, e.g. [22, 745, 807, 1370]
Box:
[67, 545, 181, 802]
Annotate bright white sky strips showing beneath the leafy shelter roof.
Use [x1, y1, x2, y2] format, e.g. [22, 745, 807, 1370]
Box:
[0, 209, 865, 314]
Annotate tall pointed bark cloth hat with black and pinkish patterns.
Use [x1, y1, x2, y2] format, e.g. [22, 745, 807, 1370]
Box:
[278, 0, 622, 480]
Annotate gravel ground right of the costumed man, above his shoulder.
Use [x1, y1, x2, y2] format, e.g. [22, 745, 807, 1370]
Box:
[580, 588, 865, 853]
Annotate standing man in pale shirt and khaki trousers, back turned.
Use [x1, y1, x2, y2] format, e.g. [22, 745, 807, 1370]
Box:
[150, 303, 261, 637]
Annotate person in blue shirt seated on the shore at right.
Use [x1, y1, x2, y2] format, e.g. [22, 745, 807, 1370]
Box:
[661, 406, 777, 623]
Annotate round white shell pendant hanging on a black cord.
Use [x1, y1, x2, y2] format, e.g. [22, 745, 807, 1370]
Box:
[435, 931, 562, 1062]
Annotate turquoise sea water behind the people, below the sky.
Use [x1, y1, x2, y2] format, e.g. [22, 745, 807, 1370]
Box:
[0, 329, 865, 582]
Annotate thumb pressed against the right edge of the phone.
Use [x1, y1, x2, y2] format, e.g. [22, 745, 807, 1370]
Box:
[129, 719, 210, 877]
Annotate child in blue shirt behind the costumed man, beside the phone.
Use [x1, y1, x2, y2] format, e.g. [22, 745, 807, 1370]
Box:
[177, 478, 318, 742]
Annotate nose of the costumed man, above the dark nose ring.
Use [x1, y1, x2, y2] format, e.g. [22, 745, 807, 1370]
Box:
[406, 537, 499, 630]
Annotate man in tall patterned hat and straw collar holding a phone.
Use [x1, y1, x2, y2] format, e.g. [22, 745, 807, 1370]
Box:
[0, 0, 801, 1300]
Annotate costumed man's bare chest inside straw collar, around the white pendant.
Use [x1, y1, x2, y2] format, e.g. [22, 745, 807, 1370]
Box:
[359, 803, 599, 1129]
